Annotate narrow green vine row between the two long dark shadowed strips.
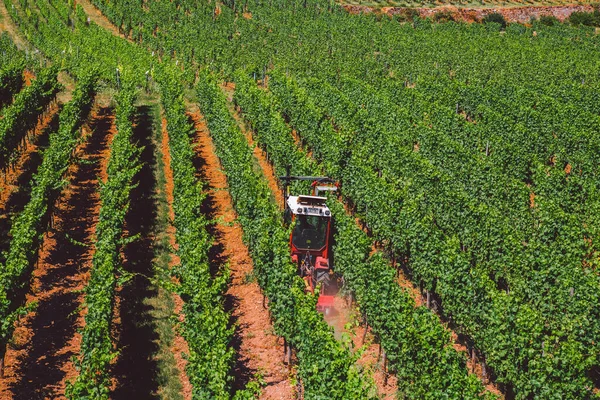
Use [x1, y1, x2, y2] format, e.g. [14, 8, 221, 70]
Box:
[66, 81, 141, 399]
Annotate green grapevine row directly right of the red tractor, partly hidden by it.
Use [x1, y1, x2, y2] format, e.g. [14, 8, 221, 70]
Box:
[234, 73, 494, 399]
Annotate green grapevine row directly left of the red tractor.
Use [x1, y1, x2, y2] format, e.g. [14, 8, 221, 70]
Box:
[197, 72, 372, 399]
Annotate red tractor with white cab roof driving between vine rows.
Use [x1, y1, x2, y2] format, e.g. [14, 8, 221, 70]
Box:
[280, 172, 337, 314]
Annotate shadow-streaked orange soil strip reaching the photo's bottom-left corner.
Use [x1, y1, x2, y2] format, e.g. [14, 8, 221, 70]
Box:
[0, 107, 115, 400]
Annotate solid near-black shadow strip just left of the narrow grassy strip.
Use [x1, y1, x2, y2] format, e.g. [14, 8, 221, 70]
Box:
[111, 106, 159, 400]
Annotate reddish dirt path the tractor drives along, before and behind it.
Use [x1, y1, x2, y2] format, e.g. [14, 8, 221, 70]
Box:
[222, 83, 397, 400]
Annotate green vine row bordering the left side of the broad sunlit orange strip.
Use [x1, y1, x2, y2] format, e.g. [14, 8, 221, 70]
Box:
[159, 69, 243, 399]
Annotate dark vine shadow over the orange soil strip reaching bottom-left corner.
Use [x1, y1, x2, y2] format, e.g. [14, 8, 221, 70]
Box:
[11, 104, 112, 400]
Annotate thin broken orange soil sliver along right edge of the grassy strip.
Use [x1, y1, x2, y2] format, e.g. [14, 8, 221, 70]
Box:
[161, 118, 192, 400]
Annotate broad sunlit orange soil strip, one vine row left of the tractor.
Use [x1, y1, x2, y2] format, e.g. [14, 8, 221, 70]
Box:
[185, 107, 295, 400]
